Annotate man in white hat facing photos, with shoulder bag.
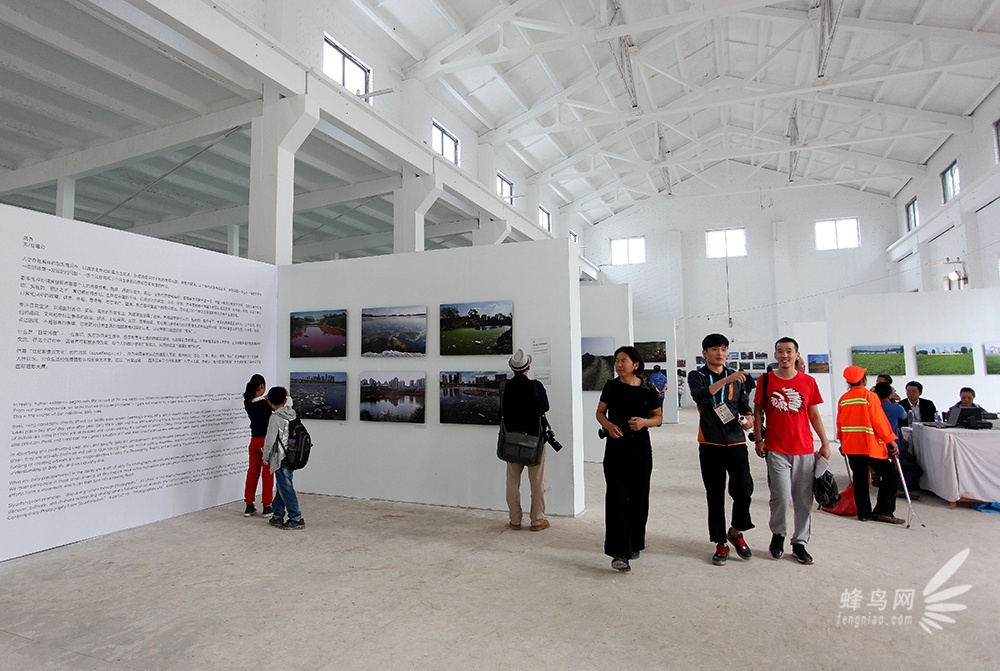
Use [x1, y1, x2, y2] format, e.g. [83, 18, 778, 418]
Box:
[501, 349, 549, 531]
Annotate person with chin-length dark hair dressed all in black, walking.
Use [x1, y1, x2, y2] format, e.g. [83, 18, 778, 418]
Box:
[597, 346, 663, 571]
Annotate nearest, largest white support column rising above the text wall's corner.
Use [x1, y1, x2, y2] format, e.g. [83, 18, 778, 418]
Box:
[247, 94, 319, 266]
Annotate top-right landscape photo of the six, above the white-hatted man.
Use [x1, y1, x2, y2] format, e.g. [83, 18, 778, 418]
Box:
[441, 301, 514, 356]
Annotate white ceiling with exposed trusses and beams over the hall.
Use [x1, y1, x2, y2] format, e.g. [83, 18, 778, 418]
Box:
[0, 0, 1000, 261]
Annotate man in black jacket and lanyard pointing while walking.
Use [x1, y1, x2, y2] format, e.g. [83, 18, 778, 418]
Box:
[688, 333, 754, 566]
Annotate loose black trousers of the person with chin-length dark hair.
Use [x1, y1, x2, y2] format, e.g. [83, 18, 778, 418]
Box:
[604, 438, 653, 559]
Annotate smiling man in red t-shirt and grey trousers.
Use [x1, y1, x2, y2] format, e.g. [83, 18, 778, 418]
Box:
[753, 338, 830, 564]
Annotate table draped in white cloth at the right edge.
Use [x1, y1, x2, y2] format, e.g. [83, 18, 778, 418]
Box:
[910, 422, 1000, 508]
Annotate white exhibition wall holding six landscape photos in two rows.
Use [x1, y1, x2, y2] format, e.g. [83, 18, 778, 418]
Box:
[277, 239, 584, 517]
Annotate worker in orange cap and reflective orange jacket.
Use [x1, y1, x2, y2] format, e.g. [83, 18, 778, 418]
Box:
[837, 366, 905, 524]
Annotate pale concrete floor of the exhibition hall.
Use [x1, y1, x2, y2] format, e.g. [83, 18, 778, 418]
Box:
[0, 411, 1000, 671]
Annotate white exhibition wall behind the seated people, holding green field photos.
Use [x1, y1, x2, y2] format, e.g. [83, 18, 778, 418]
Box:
[827, 289, 1000, 420]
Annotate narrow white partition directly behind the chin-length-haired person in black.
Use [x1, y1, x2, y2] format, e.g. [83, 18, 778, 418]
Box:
[576, 284, 632, 462]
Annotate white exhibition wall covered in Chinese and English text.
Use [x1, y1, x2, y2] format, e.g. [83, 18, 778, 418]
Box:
[0, 205, 277, 560]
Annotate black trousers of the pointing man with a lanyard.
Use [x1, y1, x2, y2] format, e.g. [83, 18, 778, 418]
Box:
[698, 443, 754, 543]
